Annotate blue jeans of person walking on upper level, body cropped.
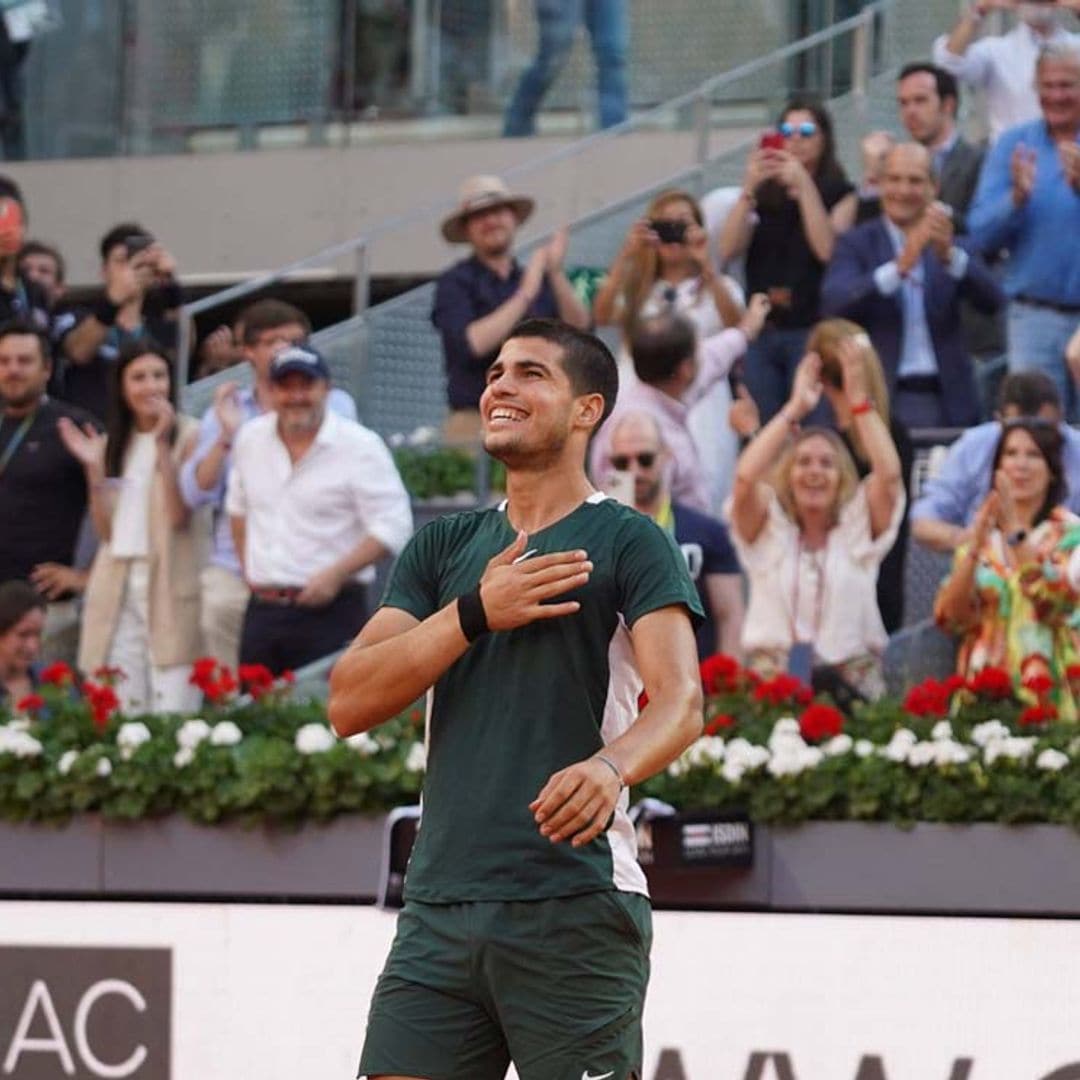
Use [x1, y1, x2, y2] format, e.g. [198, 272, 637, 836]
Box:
[502, 0, 630, 136]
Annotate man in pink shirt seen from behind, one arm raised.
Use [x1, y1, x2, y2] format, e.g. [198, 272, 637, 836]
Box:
[589, 294, 769, 514]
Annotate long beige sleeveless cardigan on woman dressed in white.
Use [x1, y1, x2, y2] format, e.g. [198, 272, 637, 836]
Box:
[79, 416, 210, 674]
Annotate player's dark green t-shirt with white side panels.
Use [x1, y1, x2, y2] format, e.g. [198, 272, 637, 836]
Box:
[383, 495, 701, 903]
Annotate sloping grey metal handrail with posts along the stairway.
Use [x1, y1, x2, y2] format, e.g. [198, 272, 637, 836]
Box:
[179, 0, 895, 384]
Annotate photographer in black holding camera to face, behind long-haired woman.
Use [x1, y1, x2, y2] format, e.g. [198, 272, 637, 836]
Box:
[59, 222, 183, 420]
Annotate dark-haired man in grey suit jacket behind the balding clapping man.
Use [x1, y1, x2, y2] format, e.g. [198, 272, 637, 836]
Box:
[896, 63, 984, 232]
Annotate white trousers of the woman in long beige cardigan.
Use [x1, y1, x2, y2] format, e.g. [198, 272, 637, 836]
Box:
[109, 558, 200, 714]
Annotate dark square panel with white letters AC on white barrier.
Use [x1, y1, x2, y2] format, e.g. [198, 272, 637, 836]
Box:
[0, 945, 173, 1080]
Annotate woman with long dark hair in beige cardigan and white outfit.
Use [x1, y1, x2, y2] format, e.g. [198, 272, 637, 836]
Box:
[60, 340, 207, 712]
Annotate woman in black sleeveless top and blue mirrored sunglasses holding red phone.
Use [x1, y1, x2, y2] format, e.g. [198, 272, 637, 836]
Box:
[719, 97, 859, 421]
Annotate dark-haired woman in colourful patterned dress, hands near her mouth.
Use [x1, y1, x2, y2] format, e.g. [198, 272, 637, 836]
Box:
[934, 417, 1080, 720]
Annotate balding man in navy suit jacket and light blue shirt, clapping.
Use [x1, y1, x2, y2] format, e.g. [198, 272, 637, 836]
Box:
[821, 143, 1004, 428]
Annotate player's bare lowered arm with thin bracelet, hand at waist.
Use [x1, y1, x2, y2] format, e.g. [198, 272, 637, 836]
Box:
[529, 605, 703, 848]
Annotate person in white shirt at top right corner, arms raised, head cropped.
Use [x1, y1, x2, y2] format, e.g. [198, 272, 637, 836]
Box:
[933, 0, 1080, 143]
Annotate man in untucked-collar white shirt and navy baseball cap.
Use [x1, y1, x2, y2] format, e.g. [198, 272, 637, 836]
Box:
[226, 346, 413, 674]
